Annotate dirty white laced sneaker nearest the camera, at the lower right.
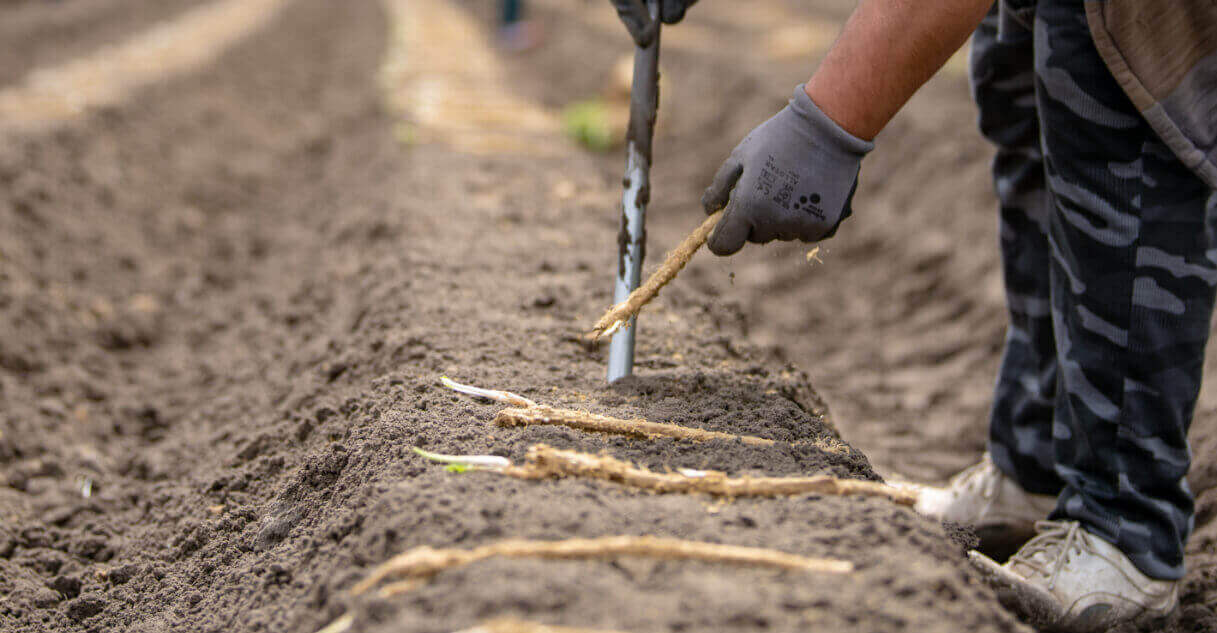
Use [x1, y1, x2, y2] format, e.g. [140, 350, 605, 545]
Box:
[968, 521, 1179, 633]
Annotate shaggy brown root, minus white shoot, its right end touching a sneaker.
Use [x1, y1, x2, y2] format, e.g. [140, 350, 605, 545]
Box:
[498, 444, 916, 505]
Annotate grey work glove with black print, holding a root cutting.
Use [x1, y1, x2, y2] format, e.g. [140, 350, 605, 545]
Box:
[701, 85, 874, 256]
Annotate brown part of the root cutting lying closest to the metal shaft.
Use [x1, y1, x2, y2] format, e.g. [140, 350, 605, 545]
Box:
[494, 404, 776, 446]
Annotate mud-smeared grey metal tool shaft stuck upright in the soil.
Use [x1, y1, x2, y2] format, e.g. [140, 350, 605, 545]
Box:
[609, 0, 660, 382]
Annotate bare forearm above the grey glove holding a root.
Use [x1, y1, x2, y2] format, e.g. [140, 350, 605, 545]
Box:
[806, 0, 993, 140]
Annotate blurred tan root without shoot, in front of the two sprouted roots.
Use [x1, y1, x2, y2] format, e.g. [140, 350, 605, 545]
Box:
[350, 537, 853, 595]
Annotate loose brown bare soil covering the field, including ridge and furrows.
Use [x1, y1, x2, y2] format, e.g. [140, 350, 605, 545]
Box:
[0, 0, 1217, 633]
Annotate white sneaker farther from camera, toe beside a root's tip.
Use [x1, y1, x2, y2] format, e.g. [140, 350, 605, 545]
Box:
[913, 453, 1056, 547]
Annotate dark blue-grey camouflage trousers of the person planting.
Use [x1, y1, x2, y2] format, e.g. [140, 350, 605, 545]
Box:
[971, 0, 1217, 579]
